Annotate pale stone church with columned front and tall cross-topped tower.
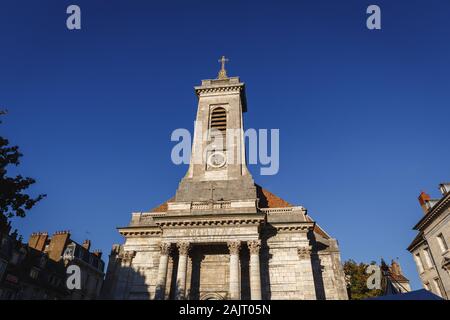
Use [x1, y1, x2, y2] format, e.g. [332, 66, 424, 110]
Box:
[103, 57, 348, 300]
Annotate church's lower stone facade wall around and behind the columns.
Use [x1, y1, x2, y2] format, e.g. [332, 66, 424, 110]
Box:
[104, 220, 347, 300]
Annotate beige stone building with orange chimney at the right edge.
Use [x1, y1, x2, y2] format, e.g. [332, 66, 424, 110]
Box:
[408, 183, 450, 299]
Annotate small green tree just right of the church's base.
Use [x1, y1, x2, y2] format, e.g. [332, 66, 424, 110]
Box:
[344, 260, 383, 300]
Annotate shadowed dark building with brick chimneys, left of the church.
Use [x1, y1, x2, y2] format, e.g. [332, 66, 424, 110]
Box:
[0, 216, 104, 300]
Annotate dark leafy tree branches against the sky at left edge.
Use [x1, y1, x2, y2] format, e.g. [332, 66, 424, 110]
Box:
[0, 110, 46, 218]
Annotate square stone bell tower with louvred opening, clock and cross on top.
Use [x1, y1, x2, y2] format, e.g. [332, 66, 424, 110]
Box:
[175, 57, 256, 201]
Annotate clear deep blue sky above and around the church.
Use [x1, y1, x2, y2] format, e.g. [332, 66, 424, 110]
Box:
[0, 0, 450, 288]
